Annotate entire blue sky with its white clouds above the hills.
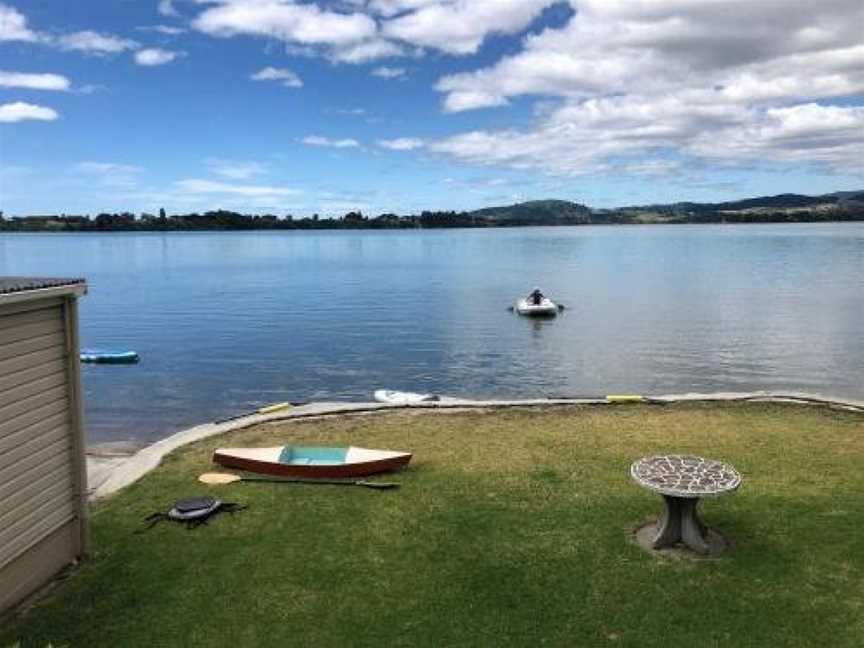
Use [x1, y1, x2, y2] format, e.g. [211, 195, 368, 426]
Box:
[0, 0, 864, 215]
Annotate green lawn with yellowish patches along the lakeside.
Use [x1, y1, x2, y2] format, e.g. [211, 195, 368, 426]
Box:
[0, 403, 864, 648]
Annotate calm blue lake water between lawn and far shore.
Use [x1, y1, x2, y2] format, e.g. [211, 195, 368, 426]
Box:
[0, 223, 864, 443]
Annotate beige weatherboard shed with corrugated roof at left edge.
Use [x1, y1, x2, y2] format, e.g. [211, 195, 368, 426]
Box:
[0, 277, 89, 612]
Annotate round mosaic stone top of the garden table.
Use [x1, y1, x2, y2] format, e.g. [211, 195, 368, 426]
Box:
[630, 455, 741, 497]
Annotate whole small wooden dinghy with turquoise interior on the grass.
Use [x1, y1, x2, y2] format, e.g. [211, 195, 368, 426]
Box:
[213, 446, 411, 479]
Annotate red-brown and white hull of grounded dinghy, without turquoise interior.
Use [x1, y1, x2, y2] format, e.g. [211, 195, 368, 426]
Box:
[213, 448, 412, 479]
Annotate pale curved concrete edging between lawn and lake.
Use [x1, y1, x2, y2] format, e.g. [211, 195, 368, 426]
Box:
[87, 392, 864, 500]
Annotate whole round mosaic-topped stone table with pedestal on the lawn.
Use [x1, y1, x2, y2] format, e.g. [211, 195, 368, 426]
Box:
[630, 455, 741, 555]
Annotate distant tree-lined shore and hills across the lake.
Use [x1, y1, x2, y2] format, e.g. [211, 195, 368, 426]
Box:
[0, 189, 864, 232]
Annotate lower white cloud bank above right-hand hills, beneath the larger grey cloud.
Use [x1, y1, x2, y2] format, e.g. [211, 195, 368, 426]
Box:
[430, 92, 864, 175]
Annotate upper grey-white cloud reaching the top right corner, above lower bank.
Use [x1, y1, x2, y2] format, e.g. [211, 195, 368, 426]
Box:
[437, 0, 864, 111]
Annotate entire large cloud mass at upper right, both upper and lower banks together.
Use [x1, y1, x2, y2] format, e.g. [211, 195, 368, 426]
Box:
[429, 0, 864, 175]
